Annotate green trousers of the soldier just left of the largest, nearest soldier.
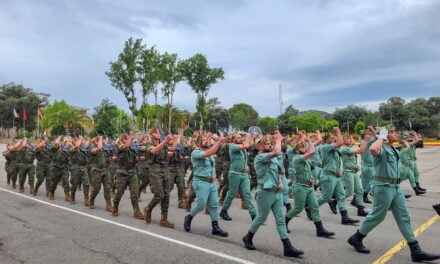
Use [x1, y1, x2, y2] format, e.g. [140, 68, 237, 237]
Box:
[318, 170, 347, 211]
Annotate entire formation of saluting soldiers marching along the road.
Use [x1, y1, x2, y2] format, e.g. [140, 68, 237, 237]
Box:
[3, 126, 440, 261]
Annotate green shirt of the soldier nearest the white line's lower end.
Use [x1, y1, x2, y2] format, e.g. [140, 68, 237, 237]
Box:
[254, 152, 281, 189]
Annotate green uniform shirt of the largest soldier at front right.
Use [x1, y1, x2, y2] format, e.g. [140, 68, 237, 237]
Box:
[373, 144, 400, 185]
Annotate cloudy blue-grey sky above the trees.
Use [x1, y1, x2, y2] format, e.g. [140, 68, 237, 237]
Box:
[0, 0, 440, 116]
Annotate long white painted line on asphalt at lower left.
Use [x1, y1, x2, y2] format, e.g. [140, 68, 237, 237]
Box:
[0, 187, 254, 264]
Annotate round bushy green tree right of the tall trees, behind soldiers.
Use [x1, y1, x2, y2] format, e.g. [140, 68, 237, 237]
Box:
[228, 103, 258, 130]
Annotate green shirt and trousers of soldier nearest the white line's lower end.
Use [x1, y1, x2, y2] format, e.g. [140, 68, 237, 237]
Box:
[249, 153, 287, 239]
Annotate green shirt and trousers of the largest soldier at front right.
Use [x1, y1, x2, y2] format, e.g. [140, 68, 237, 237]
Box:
[359, 144, 416, 242]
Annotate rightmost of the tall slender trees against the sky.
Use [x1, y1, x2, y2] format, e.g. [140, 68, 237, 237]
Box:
[181, 53, 224, 129]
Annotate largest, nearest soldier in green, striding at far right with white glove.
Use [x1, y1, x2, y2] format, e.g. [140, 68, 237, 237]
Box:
[347, 125, 440, 262]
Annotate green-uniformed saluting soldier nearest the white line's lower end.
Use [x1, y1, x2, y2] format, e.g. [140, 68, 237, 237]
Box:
[242, 132, 304, 257]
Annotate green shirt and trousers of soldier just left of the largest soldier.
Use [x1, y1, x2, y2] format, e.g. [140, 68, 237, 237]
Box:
[318, 144, 346, 211]
